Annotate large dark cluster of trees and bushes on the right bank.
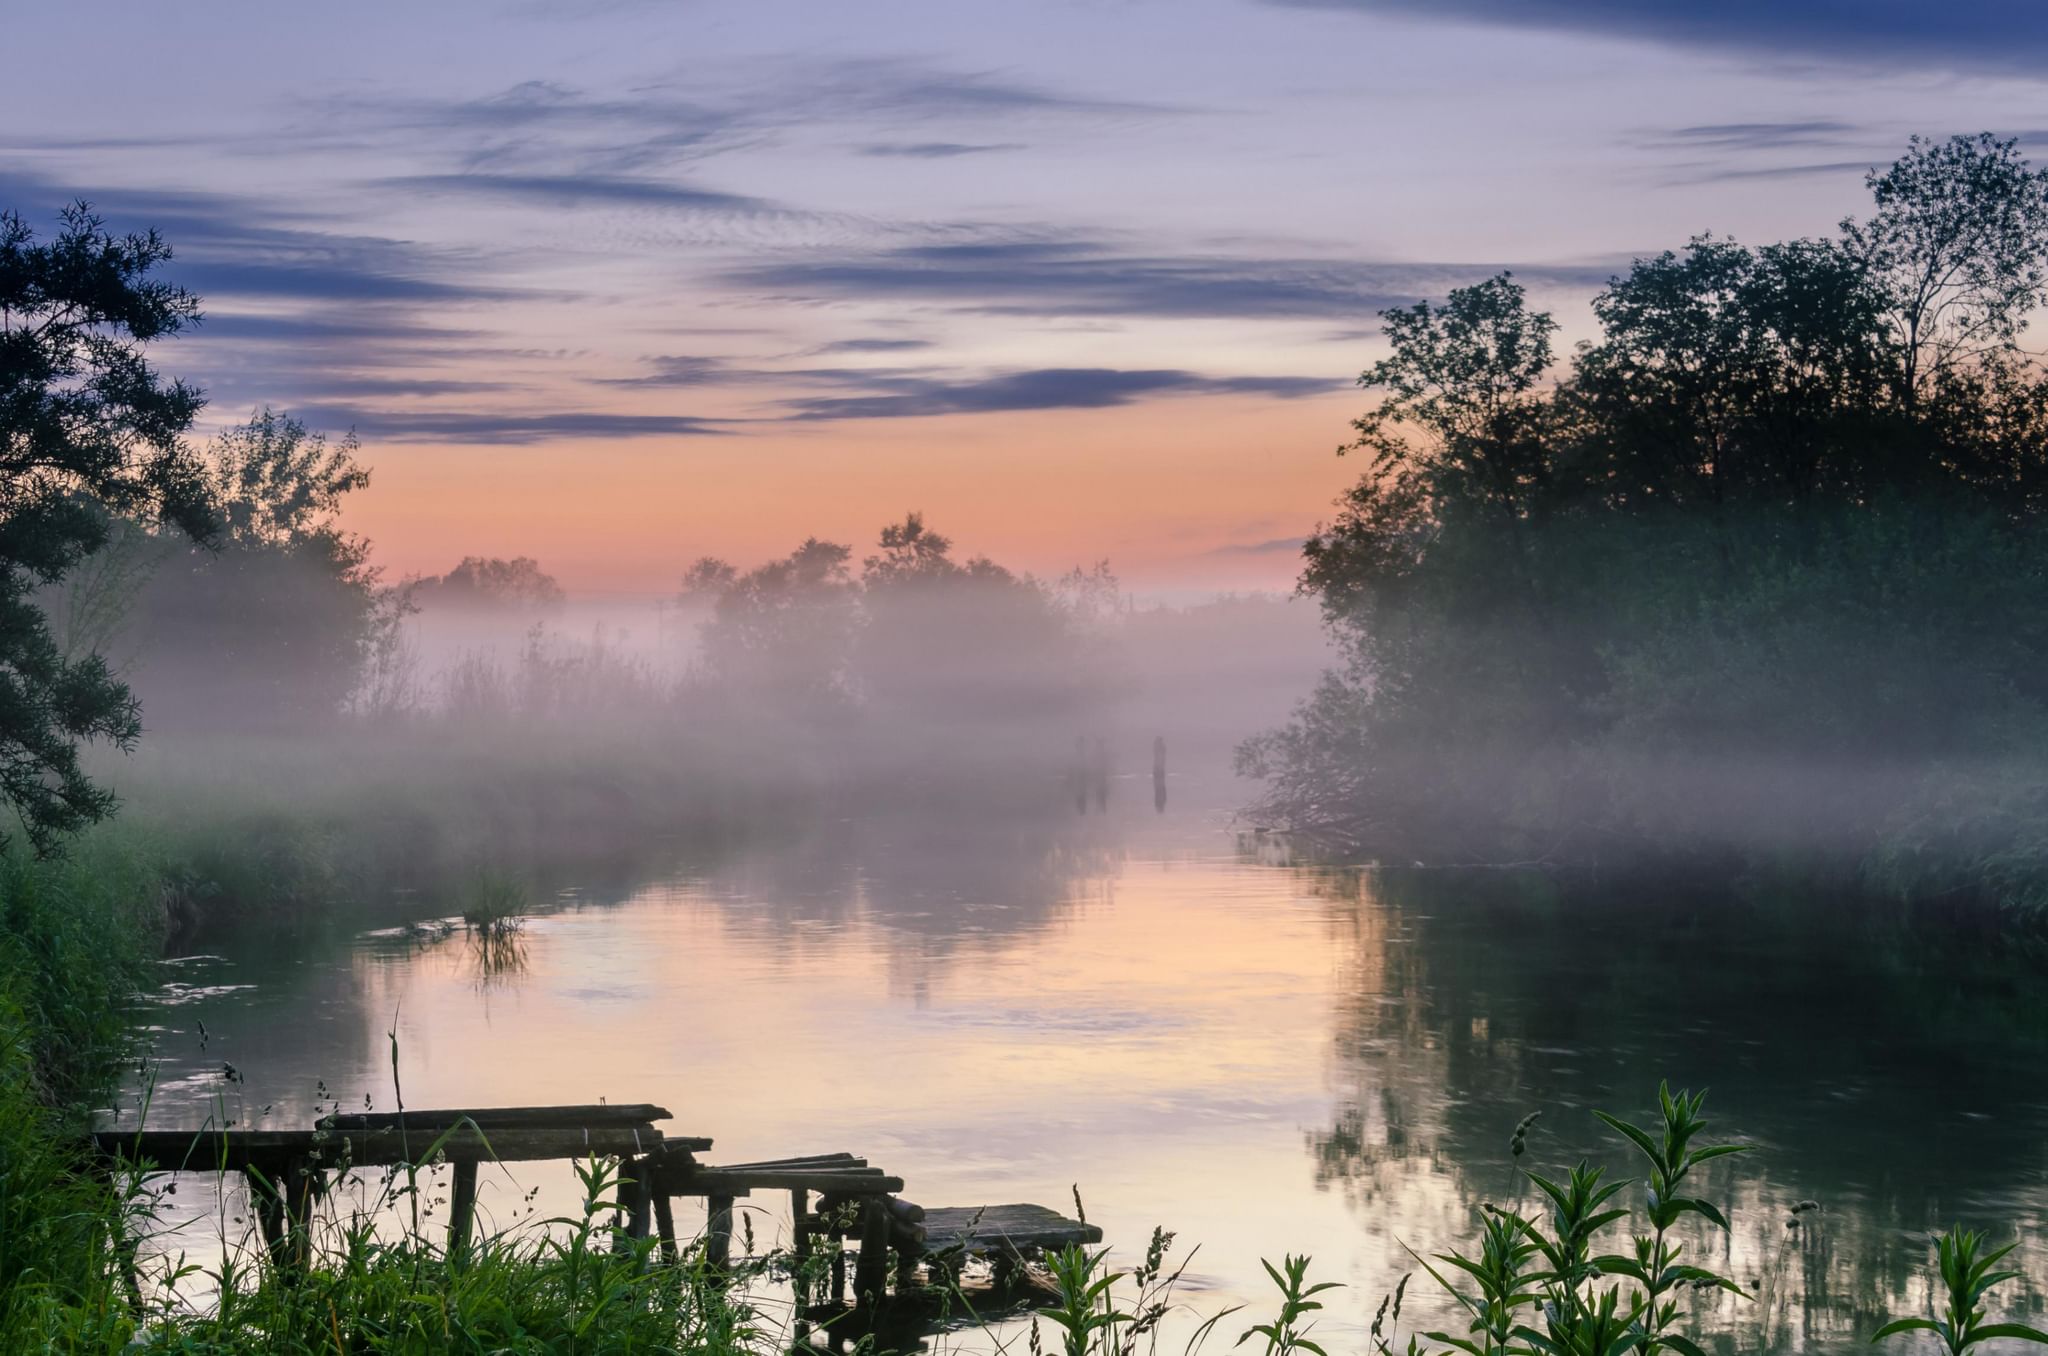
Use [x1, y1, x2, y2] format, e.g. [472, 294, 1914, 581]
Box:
[1239, 137, 2048, 901]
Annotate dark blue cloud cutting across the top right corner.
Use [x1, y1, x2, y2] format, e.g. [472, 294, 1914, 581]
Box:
[1268, 0, 2048, 74]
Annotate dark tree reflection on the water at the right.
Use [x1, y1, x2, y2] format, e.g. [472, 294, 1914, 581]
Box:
[1305, 873, 2048, 1350]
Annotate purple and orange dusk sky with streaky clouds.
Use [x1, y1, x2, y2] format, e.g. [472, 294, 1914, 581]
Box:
[0, 0, 2048, 598]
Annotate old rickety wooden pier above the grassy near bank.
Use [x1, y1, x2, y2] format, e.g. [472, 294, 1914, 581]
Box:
[92, 1102, 1102, 1319]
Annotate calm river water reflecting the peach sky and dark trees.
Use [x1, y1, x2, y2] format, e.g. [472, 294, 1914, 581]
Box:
[123, 778, 2048, 1352]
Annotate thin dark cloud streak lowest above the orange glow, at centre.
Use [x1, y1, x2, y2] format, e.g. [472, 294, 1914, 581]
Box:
[784, 367, 1346, 420]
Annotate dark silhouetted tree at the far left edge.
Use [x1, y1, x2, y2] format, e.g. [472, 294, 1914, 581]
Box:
[0, 203, 217, 852]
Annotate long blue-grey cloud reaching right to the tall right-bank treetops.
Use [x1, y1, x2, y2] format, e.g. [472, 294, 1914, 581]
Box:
[721, 240, 1614, 320]
